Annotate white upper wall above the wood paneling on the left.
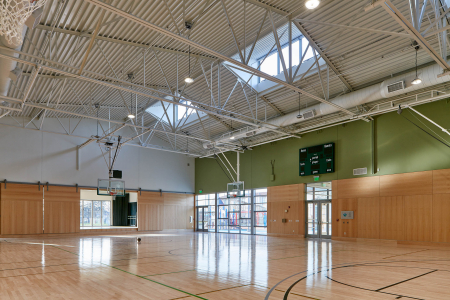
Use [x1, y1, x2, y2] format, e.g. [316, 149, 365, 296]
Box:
[0, 117, 195, 192]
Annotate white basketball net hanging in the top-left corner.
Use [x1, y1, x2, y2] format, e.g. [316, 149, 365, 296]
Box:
[0, 0, 47, 43]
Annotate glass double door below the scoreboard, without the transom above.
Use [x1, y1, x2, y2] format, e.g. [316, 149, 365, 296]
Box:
[306, 201, 331, 238]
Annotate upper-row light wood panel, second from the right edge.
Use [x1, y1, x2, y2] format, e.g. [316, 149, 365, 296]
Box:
[380, 171, 433, 197]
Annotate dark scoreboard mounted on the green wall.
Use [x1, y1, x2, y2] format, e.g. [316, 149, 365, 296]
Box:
[299, 143, 334, 176]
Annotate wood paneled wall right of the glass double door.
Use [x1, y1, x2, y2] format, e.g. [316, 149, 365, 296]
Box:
[332, 169, 450, 243]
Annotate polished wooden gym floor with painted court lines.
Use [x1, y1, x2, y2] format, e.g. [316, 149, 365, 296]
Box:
[0, 232, 450, 300]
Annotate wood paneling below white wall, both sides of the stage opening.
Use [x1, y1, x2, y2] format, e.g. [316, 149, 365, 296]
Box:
[0, 183, 194, 235]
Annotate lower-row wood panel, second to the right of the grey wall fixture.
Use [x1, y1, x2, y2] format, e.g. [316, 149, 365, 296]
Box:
[380, 196, 405, 240]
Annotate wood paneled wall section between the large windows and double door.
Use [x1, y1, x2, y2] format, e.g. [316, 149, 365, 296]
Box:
[267, 183, 305, 235]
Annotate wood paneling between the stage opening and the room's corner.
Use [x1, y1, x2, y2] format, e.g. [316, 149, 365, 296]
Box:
[138, 192, 194, 231]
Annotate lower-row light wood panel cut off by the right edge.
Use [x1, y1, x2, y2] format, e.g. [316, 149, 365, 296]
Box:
[433, 194, 450, 243]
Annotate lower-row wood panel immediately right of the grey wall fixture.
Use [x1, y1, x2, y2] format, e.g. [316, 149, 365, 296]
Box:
[358, 197, 380, 239]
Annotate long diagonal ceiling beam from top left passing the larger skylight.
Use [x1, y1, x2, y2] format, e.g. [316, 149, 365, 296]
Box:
[86, 0, 354, 116]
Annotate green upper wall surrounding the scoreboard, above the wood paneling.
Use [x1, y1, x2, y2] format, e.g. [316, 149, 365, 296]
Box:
[195, 100, 450, 193]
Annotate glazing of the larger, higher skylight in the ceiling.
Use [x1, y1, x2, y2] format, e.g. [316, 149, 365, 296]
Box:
[258, 37, 314, 82]
